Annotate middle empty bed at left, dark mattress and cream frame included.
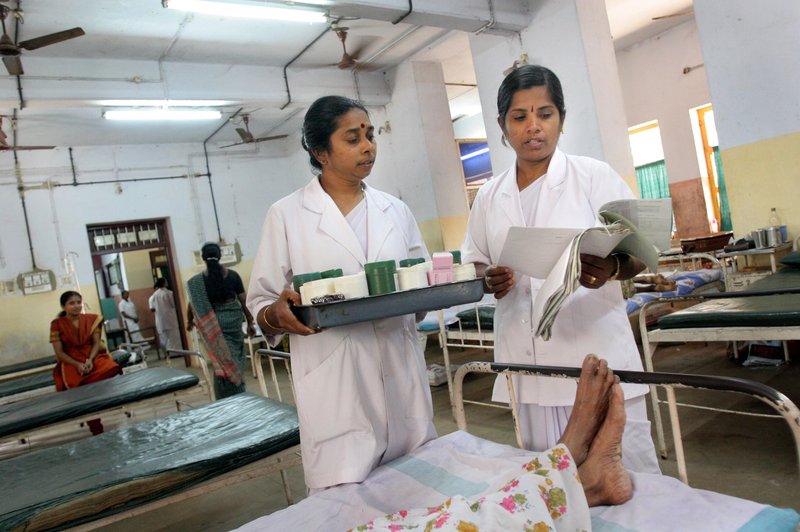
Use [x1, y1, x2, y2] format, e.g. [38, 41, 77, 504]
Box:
[0, 368, 213, 459]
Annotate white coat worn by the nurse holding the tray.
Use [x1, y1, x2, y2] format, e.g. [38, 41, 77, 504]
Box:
[247, 178, 436, 489]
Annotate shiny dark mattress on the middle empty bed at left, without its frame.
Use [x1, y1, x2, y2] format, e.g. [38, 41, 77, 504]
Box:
[0, 368, 200, 437]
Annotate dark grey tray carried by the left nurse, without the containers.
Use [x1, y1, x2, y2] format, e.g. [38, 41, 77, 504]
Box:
[292, 278, 483, 329]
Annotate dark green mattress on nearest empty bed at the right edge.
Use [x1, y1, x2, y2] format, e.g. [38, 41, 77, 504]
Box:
[658, 294, 800, 329]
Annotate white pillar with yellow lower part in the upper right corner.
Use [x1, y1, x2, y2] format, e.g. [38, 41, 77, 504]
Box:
[694, 0, 800, 236]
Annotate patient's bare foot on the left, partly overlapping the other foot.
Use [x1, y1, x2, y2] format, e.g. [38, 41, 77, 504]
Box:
[559, 355, 614, 466]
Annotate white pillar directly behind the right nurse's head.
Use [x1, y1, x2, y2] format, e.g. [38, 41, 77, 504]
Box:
[470, 0, 638, 192]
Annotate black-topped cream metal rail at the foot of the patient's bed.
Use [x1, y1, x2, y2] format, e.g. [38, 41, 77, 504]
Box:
[454, 362, 800, 485]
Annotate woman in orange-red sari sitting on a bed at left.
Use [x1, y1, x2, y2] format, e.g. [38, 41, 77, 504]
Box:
[50, 290, 122, 392]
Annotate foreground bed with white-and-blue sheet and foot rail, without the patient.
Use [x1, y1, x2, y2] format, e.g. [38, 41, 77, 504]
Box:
[239, 362, 800, 532]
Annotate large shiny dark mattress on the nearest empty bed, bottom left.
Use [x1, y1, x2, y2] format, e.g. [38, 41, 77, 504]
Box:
[0, 392, 300, 530]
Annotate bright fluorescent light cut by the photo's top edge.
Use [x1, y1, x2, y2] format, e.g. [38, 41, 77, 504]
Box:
[161, 0, 326, 22]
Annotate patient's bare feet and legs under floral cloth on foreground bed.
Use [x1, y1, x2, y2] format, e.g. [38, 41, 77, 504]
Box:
[355, 355, 633, 531]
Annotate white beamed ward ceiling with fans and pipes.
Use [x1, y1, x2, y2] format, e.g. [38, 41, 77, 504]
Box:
[0, 0, 692, 150]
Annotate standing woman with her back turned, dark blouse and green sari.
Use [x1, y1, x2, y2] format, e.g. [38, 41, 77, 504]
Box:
[186, 242, 255, 399]
